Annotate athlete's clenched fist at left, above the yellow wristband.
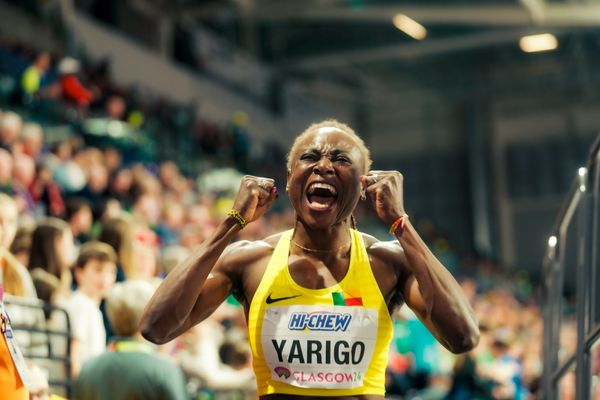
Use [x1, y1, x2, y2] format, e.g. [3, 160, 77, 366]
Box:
[233, 175, 279, 223]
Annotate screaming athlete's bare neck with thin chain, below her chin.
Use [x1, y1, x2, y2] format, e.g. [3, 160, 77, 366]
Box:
[292, 220, 351, 254]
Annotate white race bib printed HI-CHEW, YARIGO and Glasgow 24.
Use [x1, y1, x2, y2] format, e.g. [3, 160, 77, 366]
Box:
[261, 305, 378, 389]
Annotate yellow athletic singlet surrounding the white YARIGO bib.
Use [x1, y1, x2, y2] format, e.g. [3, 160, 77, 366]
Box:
[248, 230, 392, 396]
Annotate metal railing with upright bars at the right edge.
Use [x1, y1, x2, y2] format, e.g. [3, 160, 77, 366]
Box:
[542, 135, 600, 400]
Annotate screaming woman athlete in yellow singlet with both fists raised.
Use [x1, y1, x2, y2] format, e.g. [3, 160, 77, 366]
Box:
[142, 120, 479, 399]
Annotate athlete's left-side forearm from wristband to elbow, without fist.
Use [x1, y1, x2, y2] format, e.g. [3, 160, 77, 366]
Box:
[140, 217, 240, 343]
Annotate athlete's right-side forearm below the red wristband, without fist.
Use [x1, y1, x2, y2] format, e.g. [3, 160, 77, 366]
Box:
[396, 222, 479, 353]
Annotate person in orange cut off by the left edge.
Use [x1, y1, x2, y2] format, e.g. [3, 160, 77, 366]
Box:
[0, 225, 29, 400]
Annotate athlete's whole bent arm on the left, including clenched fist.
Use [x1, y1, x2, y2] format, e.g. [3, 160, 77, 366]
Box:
[140, 175, 277, 343]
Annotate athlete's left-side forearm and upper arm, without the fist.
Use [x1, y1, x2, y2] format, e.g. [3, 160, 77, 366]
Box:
[140, 217, 240, 344]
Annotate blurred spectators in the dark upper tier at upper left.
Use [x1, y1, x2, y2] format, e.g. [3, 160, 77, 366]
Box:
[0, 37, 284, 177]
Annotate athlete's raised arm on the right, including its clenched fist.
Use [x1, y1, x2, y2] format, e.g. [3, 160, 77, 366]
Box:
[360, 171, 479, 353]
